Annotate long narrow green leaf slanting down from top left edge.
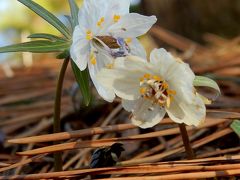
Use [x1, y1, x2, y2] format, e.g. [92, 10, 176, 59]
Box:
[18, 0, 71, 39]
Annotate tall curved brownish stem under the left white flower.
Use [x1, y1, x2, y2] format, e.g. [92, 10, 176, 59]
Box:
[53, 57, 70, 171]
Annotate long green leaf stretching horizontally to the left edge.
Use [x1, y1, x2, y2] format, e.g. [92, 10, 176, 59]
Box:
[0, 40, 70, 53]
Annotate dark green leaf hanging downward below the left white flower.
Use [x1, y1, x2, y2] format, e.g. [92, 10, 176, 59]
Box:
[71, 60, 91, 106]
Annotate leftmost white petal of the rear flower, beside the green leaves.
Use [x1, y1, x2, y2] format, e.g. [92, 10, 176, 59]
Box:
[70, 26, 91, 71]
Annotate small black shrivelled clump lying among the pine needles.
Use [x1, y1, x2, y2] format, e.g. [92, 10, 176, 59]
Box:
[90, 143, 124, 178]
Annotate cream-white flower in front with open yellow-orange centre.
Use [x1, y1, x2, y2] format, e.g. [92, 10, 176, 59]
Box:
[97, 49, 206, 128]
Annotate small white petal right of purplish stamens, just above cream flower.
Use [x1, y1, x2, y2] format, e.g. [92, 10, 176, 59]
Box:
[128, 38, 147, 59]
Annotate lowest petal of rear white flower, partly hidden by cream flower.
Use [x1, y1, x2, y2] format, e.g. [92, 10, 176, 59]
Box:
[88, 55, 115, 102]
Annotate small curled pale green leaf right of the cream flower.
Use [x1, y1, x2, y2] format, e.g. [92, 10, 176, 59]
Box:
[193, 76, 221, 94]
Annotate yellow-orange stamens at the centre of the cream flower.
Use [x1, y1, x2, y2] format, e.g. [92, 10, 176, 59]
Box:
[139, 74, 176, 108]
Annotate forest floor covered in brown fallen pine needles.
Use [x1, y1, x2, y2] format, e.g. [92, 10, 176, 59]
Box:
[0, 26, 240, 180]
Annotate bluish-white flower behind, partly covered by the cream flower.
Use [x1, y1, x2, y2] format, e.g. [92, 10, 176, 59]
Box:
[70, 0, 156, 101]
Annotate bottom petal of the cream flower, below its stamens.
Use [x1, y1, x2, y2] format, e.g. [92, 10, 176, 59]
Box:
[131, 98, 166, 128]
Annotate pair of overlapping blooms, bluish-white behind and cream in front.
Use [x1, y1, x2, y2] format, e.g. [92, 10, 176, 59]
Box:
[71, 0, 206, 128]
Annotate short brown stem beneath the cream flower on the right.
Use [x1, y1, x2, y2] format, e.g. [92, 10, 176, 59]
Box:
[179, 124, 195, 159]
